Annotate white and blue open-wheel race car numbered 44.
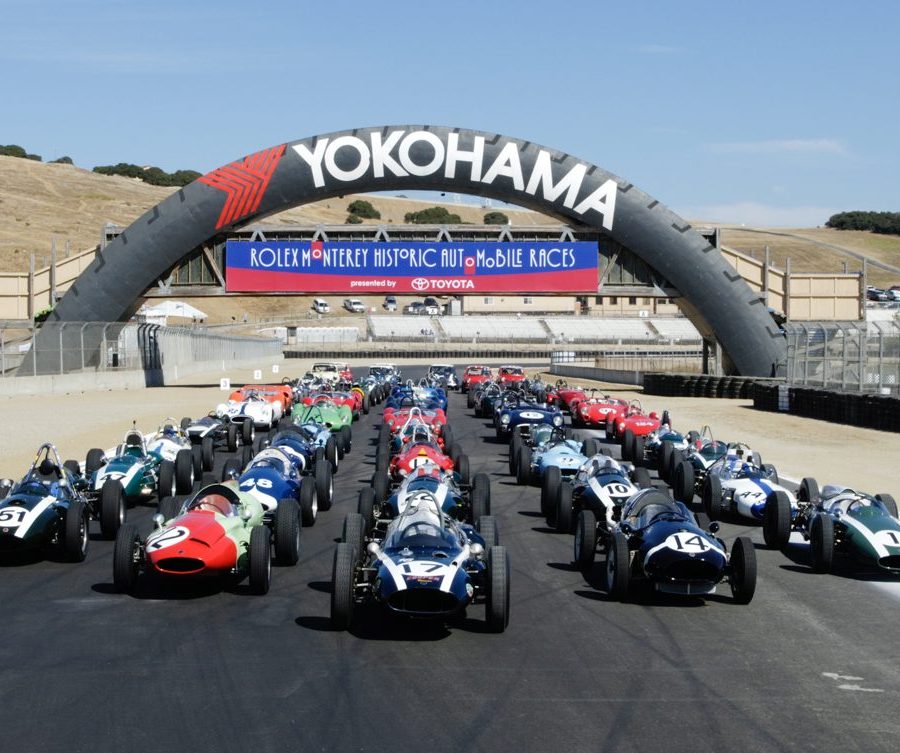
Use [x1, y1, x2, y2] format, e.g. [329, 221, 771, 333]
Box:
[700, 442, 797, 522]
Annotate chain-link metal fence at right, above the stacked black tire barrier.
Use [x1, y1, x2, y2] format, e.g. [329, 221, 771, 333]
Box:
[785, 321, 900, 395]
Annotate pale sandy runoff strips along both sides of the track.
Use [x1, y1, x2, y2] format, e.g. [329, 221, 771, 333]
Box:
[0, 360, 900, 495]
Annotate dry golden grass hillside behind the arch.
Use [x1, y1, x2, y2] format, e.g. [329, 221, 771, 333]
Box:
[0, 156, 900, 285]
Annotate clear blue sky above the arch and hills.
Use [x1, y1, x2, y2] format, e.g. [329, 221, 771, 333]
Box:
[0, 0, 900, 227]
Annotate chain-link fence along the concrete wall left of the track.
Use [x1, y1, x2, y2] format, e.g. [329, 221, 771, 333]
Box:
[14, 322, 283, 376]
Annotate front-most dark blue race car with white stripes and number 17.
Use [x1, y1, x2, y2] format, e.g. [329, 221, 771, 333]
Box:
[331, 491, 509, 633]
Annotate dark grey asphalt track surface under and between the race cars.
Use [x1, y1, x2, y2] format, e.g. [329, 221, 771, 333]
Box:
[0, 369, 900, 753]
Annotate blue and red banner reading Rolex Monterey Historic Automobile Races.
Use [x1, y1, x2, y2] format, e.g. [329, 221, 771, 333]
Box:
[225, 241, 597, 293]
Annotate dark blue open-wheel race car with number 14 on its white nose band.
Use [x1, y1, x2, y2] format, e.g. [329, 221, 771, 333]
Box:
[596, 489, 756, 604]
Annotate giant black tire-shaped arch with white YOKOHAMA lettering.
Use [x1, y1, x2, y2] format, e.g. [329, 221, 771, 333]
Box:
[37, 125, 785, 376]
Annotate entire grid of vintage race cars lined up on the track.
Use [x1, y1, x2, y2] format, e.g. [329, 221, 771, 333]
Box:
[0, 361, 900, 632]
